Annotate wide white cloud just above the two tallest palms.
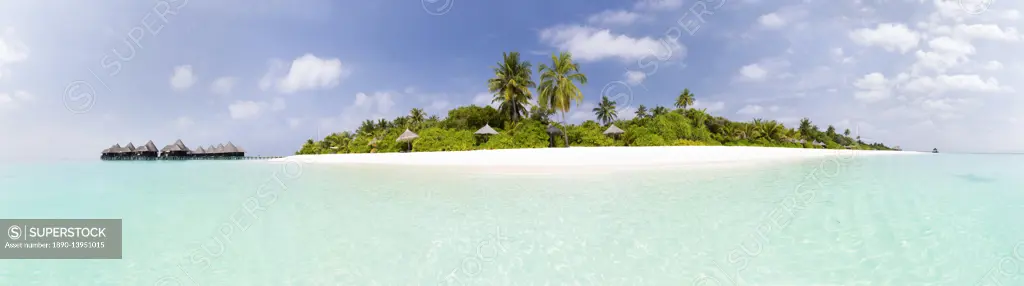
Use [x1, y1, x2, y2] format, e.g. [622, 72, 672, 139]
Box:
[540, 26, 685, 62]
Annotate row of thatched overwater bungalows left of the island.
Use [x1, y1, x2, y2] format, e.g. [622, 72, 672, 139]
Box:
[99, 139, 246, 160]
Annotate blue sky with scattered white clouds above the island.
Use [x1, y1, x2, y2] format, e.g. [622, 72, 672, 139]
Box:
[0, 0, 1024, 160]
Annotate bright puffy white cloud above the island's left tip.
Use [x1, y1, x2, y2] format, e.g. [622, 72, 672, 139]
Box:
[259, 53, 351, 93]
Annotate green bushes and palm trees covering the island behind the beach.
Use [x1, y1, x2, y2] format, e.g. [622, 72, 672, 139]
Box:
[296, 52, 892, 155]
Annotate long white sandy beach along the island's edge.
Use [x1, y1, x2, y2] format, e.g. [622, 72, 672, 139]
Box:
[270, 147, 928, 168]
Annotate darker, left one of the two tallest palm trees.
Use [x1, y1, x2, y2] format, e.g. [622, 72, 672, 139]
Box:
[487, 51, 537, 122]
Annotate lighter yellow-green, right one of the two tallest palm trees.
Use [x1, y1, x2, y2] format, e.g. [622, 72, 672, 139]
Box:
[537, 52, 587, 146]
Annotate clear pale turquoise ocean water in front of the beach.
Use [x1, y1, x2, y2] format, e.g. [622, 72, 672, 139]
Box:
[0, 154, 1024, 286]
